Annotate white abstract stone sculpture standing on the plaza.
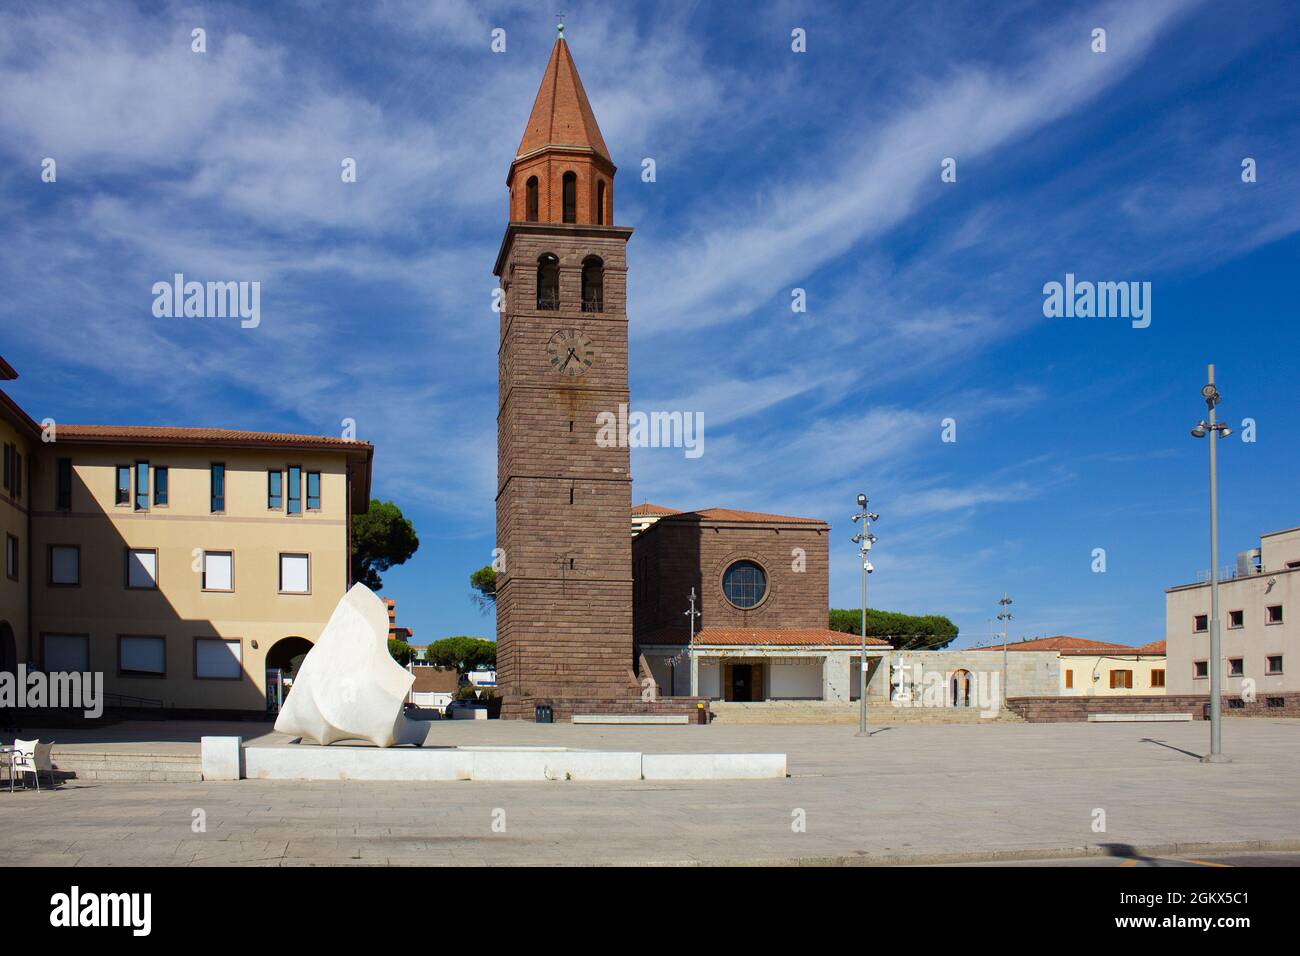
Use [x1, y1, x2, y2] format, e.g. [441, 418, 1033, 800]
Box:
[276, 584, 428, 747]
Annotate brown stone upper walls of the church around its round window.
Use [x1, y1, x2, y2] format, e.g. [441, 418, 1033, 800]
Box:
[632, 512, 829, 644]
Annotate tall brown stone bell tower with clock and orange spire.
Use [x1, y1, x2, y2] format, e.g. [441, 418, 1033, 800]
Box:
[494, 26, 638, 718]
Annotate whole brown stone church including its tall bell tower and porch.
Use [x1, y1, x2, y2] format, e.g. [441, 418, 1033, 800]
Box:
[494, 27, 888, 719]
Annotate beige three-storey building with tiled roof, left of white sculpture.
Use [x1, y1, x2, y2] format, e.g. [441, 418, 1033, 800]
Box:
[0, 356, 373, 711]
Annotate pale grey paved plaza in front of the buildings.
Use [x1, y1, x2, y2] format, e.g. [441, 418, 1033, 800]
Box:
[0, 719, 1300, 866]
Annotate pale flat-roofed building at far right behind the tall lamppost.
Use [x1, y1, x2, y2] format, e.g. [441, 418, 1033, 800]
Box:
[1165, 528, 1300, 700]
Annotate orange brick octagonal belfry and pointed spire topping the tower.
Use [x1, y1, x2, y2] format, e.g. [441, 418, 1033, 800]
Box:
[506, 26, 616, 226]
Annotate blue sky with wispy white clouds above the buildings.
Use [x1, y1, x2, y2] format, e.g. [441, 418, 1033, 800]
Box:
[0, 0, 1300, 645]
